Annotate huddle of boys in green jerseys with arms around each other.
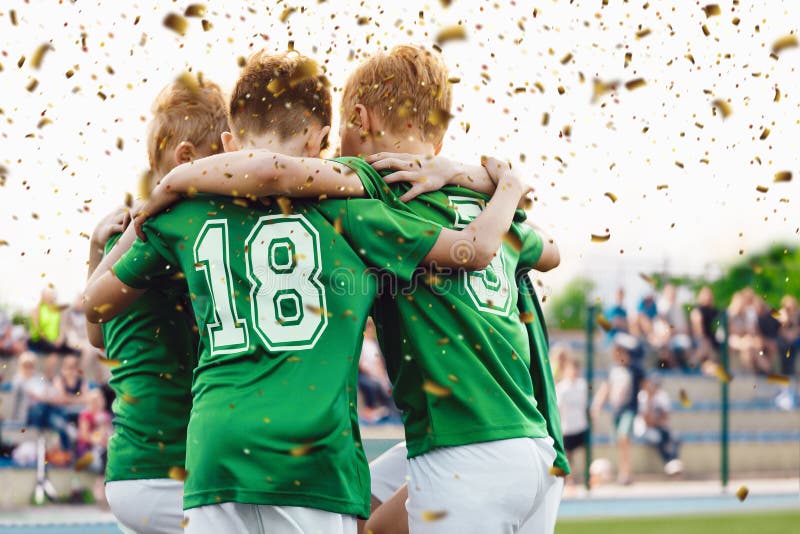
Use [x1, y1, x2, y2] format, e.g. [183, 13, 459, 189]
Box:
[84, 45, 569, 534]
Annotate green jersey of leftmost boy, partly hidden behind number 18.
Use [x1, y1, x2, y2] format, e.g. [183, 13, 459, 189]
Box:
[103, 235, 197, 482]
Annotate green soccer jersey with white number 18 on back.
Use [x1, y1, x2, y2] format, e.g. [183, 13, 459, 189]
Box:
[114, 196, 439, 517]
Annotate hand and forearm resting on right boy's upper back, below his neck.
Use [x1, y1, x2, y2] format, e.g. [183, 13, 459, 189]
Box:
[364, 152, 497, 202]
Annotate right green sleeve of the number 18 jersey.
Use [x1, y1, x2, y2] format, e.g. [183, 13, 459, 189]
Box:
[334, 199, 442, 280]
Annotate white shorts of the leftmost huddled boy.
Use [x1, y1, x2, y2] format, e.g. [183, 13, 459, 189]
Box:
[106, 478, 183, 534]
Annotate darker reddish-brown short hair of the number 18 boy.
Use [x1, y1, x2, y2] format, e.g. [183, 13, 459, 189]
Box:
[228, 50, 331, 148]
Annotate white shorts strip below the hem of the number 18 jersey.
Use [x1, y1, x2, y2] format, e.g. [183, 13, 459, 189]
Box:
[185, 502, 356, 534]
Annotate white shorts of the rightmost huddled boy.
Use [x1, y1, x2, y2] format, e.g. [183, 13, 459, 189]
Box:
[406, 438, 561, 534]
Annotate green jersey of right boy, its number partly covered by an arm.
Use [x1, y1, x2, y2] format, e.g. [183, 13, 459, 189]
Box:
[338, 158, 548, 457]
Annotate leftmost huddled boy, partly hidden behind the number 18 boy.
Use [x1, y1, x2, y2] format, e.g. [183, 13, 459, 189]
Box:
[87, 76, 227, 534]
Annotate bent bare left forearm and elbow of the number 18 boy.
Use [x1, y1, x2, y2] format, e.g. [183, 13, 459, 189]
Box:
[83, 225, 145, 323]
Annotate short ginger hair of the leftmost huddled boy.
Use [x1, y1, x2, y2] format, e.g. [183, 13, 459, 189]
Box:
[147, 74, 228, 174]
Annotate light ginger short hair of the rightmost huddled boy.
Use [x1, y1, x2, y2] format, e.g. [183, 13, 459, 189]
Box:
[342, 45, 452, 144]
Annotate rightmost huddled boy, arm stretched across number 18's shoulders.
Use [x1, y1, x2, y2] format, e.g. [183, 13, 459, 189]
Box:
[126, 47, 568, 531]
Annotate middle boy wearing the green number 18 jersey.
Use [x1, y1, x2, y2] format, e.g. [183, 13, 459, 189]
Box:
[85, 50, 526, 532]
